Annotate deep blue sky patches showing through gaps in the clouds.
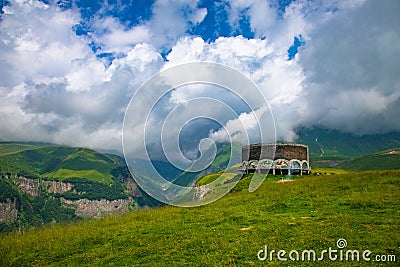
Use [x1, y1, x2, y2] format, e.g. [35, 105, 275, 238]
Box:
[64, 0, 304, 60]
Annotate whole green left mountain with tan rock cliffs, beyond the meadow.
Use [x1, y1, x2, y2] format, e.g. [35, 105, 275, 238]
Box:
[0, 142, 159, 232]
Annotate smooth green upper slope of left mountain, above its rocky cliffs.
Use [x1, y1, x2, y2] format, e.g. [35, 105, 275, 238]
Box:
[0, 143, 120, 183]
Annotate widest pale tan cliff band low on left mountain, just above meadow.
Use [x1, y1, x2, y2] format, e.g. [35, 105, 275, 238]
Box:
[60, 198, 135, 218]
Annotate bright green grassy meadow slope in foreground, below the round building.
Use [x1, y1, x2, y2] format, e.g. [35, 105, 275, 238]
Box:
[0, 171, 400, 266]
